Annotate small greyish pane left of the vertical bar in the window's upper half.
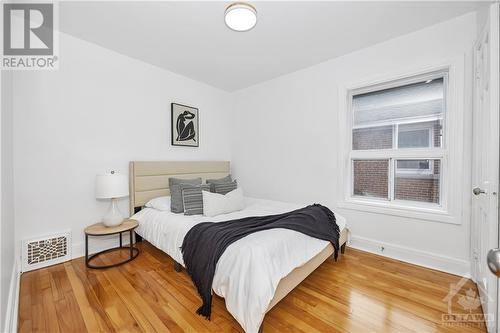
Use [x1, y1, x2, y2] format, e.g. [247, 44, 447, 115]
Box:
[352, 126, 392, 150]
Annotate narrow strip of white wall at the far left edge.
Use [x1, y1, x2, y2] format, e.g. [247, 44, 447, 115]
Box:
[0, 72, 17, 332]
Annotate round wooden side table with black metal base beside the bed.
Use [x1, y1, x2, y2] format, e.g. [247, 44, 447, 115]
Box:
[85, 220, 139, 269]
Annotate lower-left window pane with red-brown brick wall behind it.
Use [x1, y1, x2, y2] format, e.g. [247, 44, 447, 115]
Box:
[353, 160, 389, 199]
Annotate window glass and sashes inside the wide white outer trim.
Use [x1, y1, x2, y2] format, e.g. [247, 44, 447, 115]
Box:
[349, 71, 448, 206]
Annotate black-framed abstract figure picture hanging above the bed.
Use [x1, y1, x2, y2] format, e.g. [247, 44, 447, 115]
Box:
[170, 103, 200, 147]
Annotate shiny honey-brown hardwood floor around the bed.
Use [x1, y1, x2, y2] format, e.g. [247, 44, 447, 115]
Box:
[19, 242, 485, 333]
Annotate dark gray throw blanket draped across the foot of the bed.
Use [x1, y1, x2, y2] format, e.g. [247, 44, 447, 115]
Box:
[181, 204, 340, 319]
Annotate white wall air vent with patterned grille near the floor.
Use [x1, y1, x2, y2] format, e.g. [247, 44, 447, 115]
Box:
[23, 232, 71, 272]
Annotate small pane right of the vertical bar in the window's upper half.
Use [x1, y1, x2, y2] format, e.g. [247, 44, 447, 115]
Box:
[398, 120, 441, 148]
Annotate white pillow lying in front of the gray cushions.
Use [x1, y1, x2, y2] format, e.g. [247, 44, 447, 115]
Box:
[202, 187, 245, 216]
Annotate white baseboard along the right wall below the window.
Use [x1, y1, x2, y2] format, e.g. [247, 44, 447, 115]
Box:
[349, 236, 471, 278]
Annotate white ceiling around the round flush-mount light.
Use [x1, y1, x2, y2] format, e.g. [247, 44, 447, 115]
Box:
[59, 1, 481, 91]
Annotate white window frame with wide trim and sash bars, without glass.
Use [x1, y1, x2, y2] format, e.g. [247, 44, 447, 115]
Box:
[338, 57, 465, 224]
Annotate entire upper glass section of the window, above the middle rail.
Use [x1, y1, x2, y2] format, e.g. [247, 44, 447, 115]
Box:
[352, 77, 446, 150]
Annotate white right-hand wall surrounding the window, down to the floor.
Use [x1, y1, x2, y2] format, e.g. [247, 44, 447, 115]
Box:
[232, 13, 476, 275]
